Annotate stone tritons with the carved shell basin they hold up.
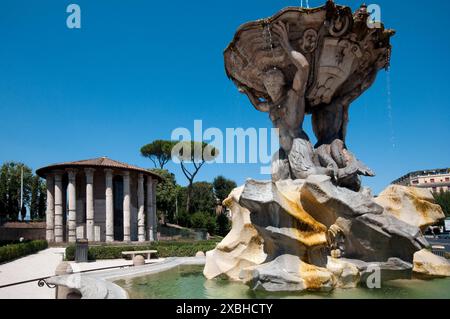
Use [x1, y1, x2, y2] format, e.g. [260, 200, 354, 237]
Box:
[225, 1, 394, 191]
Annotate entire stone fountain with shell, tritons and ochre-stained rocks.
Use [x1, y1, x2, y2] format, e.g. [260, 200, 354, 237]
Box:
[204, 0, 450, 292]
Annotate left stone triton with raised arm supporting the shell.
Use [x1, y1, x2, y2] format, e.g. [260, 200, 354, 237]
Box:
[241, 22, 331, 180]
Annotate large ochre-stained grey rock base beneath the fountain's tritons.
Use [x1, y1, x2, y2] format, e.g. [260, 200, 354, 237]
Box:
[204, 175, 448, 291]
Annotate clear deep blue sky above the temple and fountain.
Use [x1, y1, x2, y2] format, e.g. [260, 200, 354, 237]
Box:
[0, 0, 450, 193]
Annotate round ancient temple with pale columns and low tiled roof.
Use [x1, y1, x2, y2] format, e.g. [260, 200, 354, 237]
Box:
[36, 157, 161, 243]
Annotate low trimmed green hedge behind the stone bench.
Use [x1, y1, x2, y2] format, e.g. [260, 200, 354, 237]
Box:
[66, 240, 219, 261]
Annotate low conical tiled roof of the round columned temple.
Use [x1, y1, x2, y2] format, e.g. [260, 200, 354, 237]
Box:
[36, 157, 162, 181]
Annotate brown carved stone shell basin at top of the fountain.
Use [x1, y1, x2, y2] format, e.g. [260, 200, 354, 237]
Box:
[224, 1, 395, 112]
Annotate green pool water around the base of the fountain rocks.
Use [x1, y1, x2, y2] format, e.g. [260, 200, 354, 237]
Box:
[116, 266, 450, 299]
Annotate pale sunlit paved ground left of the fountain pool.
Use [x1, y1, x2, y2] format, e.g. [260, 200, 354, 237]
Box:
[0, 248, 162, 299]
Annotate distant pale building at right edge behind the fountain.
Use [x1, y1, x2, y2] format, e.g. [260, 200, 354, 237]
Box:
[392, 168, 450, 193]
